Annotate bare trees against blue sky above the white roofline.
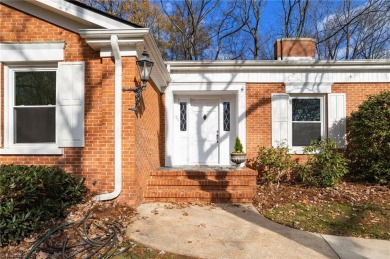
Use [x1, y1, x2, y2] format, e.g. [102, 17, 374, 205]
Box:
[78, 0, 390, 60]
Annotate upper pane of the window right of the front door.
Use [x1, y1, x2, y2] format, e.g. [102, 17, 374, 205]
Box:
[292, 99, 321, 121]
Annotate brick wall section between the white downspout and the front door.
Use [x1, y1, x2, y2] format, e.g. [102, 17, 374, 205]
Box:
[120, 59, 165, 204]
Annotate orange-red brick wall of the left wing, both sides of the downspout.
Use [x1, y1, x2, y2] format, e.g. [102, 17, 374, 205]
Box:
[0, 4, 164, 205]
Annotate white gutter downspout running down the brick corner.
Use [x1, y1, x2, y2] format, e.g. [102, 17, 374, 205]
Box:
[93, 35, 122, 201]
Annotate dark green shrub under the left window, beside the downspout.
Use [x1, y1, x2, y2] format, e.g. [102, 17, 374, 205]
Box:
[0, 165, 87, 246]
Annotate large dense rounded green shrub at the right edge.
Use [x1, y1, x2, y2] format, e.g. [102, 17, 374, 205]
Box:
[347, 91, 390, 184]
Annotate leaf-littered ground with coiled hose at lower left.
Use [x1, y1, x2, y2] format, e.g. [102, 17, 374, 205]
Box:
[0, 201, 190, 259]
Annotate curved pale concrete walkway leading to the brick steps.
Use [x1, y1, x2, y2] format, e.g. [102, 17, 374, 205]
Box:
[127, 203, 390, 259]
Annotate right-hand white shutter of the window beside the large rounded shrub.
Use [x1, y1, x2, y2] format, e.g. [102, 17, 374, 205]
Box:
[328, 94, 346, 148]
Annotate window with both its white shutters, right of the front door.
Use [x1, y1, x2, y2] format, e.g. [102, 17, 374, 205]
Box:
[271, 94, 346, 153]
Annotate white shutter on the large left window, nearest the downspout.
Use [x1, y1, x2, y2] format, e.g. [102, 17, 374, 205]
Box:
[56, 62, 84, 147]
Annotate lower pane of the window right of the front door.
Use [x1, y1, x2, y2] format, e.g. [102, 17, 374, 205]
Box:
[292, 122, 321, 147]
